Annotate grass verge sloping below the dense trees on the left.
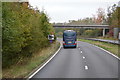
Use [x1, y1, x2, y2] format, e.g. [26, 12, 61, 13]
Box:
[2, 42, 60, 78]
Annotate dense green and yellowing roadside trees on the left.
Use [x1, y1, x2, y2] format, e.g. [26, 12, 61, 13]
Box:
[2, 2, 54, 68]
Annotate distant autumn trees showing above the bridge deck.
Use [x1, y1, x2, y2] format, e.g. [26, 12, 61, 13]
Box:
[53, 8, 108, 25]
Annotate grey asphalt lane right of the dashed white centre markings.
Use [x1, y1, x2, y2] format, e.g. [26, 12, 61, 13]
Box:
[78, 41, 120, 78]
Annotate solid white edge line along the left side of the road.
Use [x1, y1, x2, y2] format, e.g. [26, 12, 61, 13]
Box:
[28, 44, 61, 80]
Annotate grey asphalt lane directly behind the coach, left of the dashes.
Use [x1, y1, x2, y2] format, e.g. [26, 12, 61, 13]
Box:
[33, 48, 86, 78]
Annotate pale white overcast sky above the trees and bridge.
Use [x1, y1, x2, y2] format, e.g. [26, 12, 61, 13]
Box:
[29, 0, 119, 22]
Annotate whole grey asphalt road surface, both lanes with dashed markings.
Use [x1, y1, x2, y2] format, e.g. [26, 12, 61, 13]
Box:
[30, 39, 120, 78]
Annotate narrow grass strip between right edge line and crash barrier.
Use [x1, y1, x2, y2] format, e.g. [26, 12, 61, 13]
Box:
[79, 39, 120, 57]
